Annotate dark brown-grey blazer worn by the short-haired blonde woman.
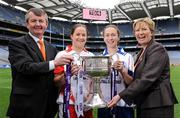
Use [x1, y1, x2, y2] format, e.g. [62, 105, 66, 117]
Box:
[119, 40, 177, 108]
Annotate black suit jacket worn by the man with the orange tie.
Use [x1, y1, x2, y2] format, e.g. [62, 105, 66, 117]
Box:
[7, 34, 58, 118]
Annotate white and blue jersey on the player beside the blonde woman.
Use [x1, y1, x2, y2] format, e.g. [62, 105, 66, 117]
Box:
[100, 48, 134, 107]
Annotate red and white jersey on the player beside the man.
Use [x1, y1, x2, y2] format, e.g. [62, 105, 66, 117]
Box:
[54, 46, 94, 104]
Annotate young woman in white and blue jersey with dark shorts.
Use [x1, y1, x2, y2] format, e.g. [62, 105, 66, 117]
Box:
[98, 25, 134, 118]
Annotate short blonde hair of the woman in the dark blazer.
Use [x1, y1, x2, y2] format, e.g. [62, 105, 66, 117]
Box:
[133, 17, 155, 34]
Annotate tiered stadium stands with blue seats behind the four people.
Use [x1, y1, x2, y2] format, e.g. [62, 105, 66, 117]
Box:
[0, 4, 180, 64]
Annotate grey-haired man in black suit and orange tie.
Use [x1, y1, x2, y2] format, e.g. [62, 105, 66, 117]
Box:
[7, 8, 73, 118]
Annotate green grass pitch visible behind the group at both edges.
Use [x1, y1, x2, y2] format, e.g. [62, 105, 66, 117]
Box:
[0, 67, 180, 118]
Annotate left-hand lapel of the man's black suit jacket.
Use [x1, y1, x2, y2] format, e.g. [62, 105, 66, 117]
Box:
[25, 34, 44, 61]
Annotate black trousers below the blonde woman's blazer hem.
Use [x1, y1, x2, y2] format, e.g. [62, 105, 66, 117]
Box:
[137, 105, 174, 118]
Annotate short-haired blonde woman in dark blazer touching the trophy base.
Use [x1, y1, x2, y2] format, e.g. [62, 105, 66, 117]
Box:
[108, 18, 178, 118]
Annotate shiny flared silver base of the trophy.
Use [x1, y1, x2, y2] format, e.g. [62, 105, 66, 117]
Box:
[85, 93, 107, 108]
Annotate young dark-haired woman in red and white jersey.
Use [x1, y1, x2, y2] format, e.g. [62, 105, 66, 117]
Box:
[54, 24, 94, 118]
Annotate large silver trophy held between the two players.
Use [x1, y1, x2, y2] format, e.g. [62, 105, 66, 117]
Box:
[83, 56, 111, 108]
